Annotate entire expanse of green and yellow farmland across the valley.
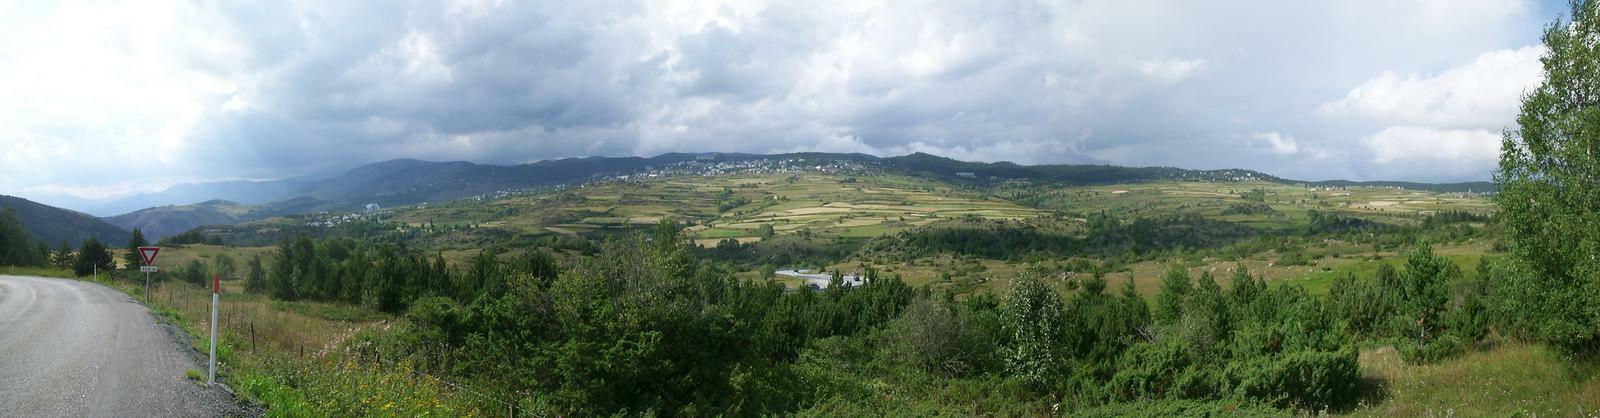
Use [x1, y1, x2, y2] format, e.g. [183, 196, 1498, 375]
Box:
[184, 173, 1493, 301]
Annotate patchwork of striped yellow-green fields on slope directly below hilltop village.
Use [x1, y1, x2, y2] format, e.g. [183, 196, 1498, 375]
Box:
[380, 175, 1046, 247]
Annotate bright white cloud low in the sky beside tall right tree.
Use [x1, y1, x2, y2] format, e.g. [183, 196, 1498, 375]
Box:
[1320, 45, 1546, 130]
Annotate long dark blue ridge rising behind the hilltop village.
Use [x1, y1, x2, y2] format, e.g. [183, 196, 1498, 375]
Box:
[285, 152, 1493, 207]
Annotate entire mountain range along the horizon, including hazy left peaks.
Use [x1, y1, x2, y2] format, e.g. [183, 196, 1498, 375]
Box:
[3, 152, 1494, 245]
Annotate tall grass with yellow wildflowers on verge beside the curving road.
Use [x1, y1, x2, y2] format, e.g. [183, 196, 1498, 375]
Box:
[130, 282, 498, 416]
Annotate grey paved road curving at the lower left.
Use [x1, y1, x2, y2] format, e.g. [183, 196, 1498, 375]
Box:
[0, 275, 251, 416]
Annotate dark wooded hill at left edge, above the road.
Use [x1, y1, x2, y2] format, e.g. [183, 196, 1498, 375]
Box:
[0, 195, 133, 248]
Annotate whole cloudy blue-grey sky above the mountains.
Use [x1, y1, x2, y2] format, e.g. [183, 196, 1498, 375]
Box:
[0, 0, 1565, 199]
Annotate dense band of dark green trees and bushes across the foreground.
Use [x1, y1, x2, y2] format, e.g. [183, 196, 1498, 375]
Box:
[236, 221, 1493, 415]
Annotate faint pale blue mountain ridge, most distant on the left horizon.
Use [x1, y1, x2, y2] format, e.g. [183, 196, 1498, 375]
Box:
[86, 179, 310, 216]
